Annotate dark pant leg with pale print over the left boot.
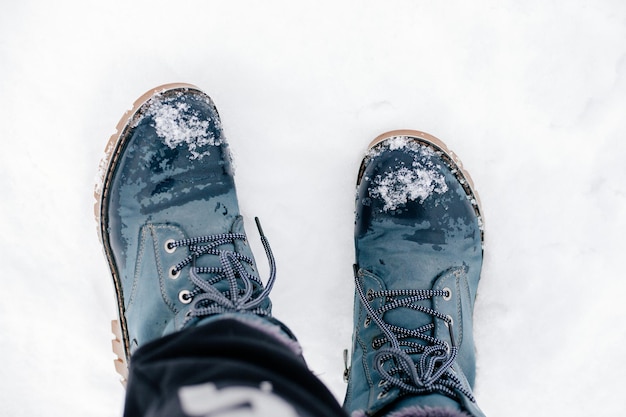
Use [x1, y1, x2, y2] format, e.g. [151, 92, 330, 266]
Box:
[124, 318, 345, 417]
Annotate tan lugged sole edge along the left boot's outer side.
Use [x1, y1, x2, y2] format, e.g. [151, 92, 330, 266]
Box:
[94, 83, 201, 387]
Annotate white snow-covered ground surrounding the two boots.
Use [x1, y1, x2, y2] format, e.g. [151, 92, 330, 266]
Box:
[0, 0, 626, 417]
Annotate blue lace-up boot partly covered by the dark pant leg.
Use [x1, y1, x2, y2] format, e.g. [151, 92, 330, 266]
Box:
[95, 84, 289, 384]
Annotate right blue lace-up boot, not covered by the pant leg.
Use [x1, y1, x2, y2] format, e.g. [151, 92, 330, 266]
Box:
[344, 131, 483, 417]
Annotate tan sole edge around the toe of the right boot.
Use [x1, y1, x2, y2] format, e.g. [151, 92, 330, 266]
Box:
[357, 129, 485, 242]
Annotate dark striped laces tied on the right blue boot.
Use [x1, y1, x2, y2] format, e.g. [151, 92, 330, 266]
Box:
[355, 265, 476, 402]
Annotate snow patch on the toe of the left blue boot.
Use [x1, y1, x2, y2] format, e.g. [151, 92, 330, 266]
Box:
[148, 96, 221, 160]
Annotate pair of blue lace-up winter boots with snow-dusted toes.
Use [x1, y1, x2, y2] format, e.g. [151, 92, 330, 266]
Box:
[95, 84, 483, 417]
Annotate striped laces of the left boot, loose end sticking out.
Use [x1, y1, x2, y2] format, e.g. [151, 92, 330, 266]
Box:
[167, 218, 276, 326]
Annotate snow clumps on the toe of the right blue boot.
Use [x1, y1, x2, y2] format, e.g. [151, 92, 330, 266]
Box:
[367, 136, 448, 211]
